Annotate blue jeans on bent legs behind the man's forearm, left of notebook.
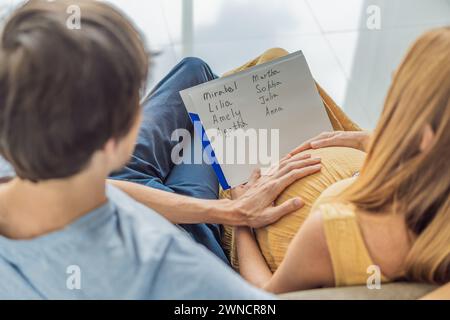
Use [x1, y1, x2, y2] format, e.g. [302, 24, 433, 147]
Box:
[111, 58, 229, 264]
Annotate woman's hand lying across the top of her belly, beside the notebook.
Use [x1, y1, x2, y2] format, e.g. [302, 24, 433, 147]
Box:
[290, 131, 370, 156]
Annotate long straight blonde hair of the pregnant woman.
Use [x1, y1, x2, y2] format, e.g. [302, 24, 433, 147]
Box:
[343, 27, 450, 283]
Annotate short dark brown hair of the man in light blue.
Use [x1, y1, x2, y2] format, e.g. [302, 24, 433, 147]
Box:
[0, 0, 149, 182]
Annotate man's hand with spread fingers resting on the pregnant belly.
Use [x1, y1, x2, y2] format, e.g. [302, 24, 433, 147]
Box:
[232, 155, 321, 228]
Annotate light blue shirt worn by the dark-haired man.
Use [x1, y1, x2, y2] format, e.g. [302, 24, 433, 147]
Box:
[0, 186, 273, 299]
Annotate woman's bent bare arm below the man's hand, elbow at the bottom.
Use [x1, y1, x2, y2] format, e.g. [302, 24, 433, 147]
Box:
[236, 212, 334, 294]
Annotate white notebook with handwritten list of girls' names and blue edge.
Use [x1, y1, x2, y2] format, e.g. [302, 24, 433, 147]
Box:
[180, 51, 332, 190]
